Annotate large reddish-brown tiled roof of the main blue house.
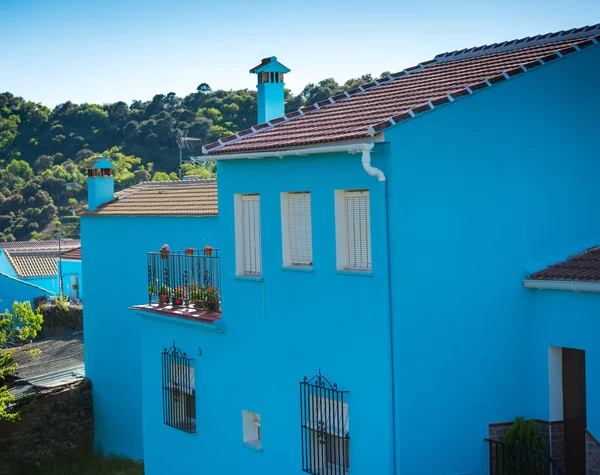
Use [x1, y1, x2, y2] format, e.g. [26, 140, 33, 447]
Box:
[202, 24, 600, 156]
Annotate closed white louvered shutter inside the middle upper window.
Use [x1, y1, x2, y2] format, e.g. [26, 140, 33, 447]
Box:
[287, 193, 312, 266]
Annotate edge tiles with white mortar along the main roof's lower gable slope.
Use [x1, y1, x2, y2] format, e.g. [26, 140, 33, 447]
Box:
[368, 35, 600, 136]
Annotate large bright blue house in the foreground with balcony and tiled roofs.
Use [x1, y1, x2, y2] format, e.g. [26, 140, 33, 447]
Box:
[82, 25, 600, 475]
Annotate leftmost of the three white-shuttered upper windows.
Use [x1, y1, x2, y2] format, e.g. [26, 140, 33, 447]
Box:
[235, 195, 262, 276]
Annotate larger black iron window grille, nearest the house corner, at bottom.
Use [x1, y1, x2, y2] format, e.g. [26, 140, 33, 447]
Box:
[300, 370, 350, 475]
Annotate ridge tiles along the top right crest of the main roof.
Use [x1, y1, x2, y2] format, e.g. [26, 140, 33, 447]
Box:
[435, 23, 600, 62]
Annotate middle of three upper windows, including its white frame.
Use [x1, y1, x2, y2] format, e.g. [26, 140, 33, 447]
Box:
[281, 191, 313, 268]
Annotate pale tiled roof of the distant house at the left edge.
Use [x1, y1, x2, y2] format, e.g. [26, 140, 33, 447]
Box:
[0, 239, 81, 277]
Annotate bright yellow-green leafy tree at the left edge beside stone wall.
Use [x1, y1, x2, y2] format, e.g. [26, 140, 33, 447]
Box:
[0, 302, 43, 422]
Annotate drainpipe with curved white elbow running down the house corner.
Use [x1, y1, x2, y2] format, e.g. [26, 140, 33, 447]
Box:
[358, 143, 397, 475]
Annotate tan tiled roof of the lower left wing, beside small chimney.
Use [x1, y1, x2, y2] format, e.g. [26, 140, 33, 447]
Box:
[83, 180, 218, 216]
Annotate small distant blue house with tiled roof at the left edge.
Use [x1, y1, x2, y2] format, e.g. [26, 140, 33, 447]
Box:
[0, 239, 81, 302]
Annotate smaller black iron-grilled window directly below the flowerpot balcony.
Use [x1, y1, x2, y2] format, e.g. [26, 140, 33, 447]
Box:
[162, 342, 196, 433]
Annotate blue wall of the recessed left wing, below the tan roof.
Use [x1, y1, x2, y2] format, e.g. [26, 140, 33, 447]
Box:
[81, 216, 219, 459]
